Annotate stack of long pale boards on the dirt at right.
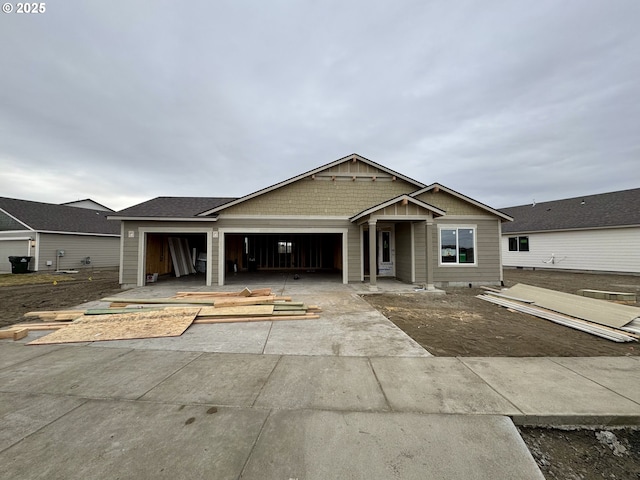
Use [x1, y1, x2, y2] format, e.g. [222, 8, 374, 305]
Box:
[477, 284, 640, 342]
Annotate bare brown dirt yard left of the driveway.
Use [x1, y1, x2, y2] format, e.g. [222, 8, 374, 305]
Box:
[0, 269, 122, 327]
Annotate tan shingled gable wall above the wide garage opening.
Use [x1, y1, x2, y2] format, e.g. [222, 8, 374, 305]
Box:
[222, 177, 416, 217]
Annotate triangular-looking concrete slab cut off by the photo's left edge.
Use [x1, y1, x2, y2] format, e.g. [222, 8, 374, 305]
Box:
[0, 393, 86, 452]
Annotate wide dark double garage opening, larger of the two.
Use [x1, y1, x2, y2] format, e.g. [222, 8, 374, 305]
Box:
[225, 233, 343, 280]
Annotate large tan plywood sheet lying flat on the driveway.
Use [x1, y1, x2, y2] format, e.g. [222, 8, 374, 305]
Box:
[29, 307, 200, 345]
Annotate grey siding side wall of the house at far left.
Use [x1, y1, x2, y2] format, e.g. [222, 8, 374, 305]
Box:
[37, 233, 120, 272]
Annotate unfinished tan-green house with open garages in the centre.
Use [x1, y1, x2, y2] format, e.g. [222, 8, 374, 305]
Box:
[109, 154, 511, 288]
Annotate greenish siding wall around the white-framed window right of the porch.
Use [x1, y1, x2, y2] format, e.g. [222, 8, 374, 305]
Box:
[432, 217, 502, 286]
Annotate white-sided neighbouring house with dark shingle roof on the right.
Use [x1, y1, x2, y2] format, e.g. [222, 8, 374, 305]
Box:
[500, 188, 640, 274]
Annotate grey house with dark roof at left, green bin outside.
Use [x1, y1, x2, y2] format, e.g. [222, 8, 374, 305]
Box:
[0, 197, 120, 272]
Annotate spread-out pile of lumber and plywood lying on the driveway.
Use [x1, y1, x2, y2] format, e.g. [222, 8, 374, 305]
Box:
[0, 288, 321, 344]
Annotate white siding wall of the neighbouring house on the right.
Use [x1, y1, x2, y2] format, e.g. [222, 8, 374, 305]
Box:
[502, 227, 640, 273]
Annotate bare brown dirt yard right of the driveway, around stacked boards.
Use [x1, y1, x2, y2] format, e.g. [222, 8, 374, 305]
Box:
[364, 269, 640, 357]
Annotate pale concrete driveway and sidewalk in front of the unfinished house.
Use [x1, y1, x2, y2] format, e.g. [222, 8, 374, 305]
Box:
[0, 278, 640, 480]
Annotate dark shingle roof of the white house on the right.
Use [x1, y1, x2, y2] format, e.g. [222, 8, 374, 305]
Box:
[500, 188, 640, 233]
